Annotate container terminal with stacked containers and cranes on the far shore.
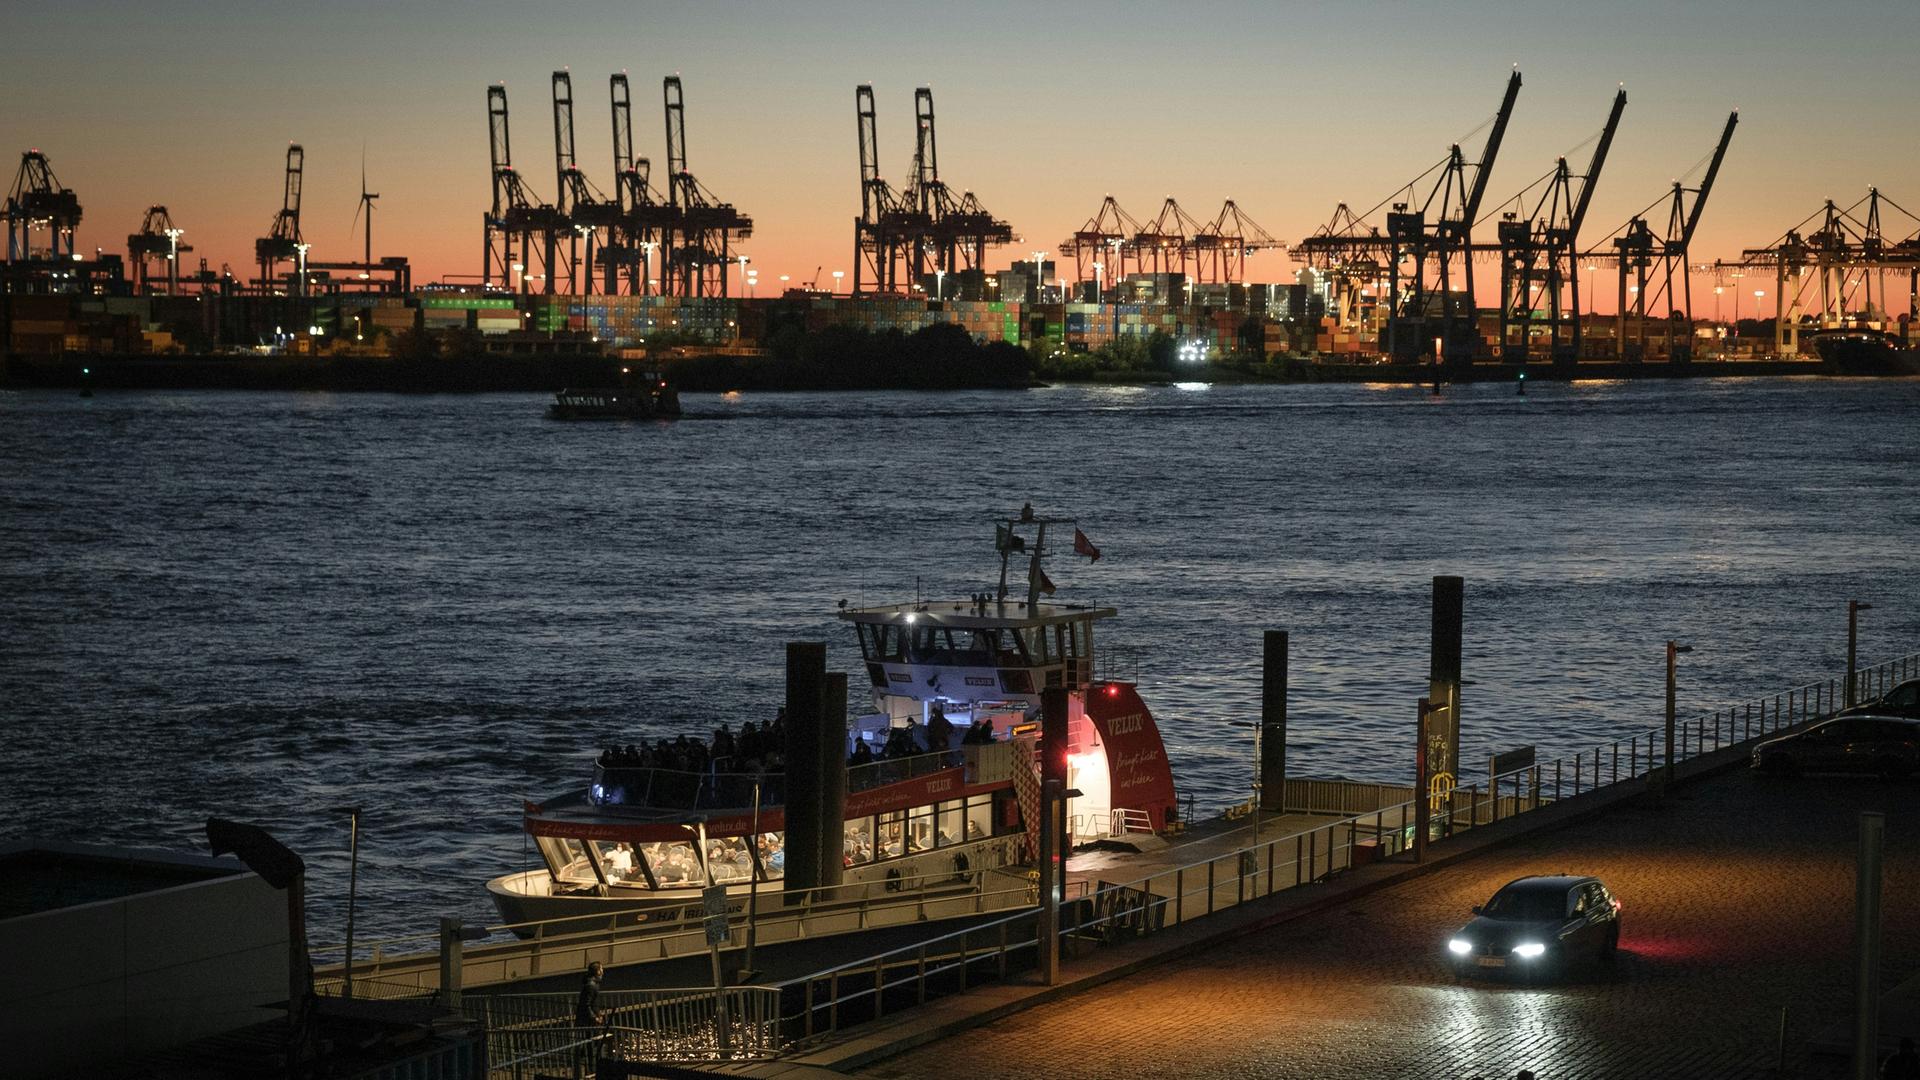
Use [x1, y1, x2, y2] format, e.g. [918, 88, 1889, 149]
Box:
[0, 69, 1920, 379]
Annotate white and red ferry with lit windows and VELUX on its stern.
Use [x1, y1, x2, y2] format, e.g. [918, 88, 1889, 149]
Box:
[488, 507, 1175, 924]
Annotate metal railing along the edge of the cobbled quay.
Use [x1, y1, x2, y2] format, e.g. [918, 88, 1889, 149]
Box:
[780, 653, 1920, 1049]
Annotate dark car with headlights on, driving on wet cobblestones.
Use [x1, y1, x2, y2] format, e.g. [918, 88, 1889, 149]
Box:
[1446, 874, 1620, 978]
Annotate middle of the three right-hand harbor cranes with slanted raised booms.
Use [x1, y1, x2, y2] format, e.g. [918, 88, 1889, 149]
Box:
[1498, 86, 1626, 363]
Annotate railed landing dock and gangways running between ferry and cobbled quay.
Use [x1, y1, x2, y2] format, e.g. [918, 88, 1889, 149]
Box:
[307, 641, 1920, 1067]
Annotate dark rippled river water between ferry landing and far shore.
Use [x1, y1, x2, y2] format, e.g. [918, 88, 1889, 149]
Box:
[0, 379, 1920, 940]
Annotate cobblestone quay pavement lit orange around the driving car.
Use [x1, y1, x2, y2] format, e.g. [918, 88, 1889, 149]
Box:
[862, 769, 1920, 1080]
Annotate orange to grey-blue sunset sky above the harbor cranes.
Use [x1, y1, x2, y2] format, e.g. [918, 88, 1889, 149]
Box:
[0, 0, 1920, 309]
